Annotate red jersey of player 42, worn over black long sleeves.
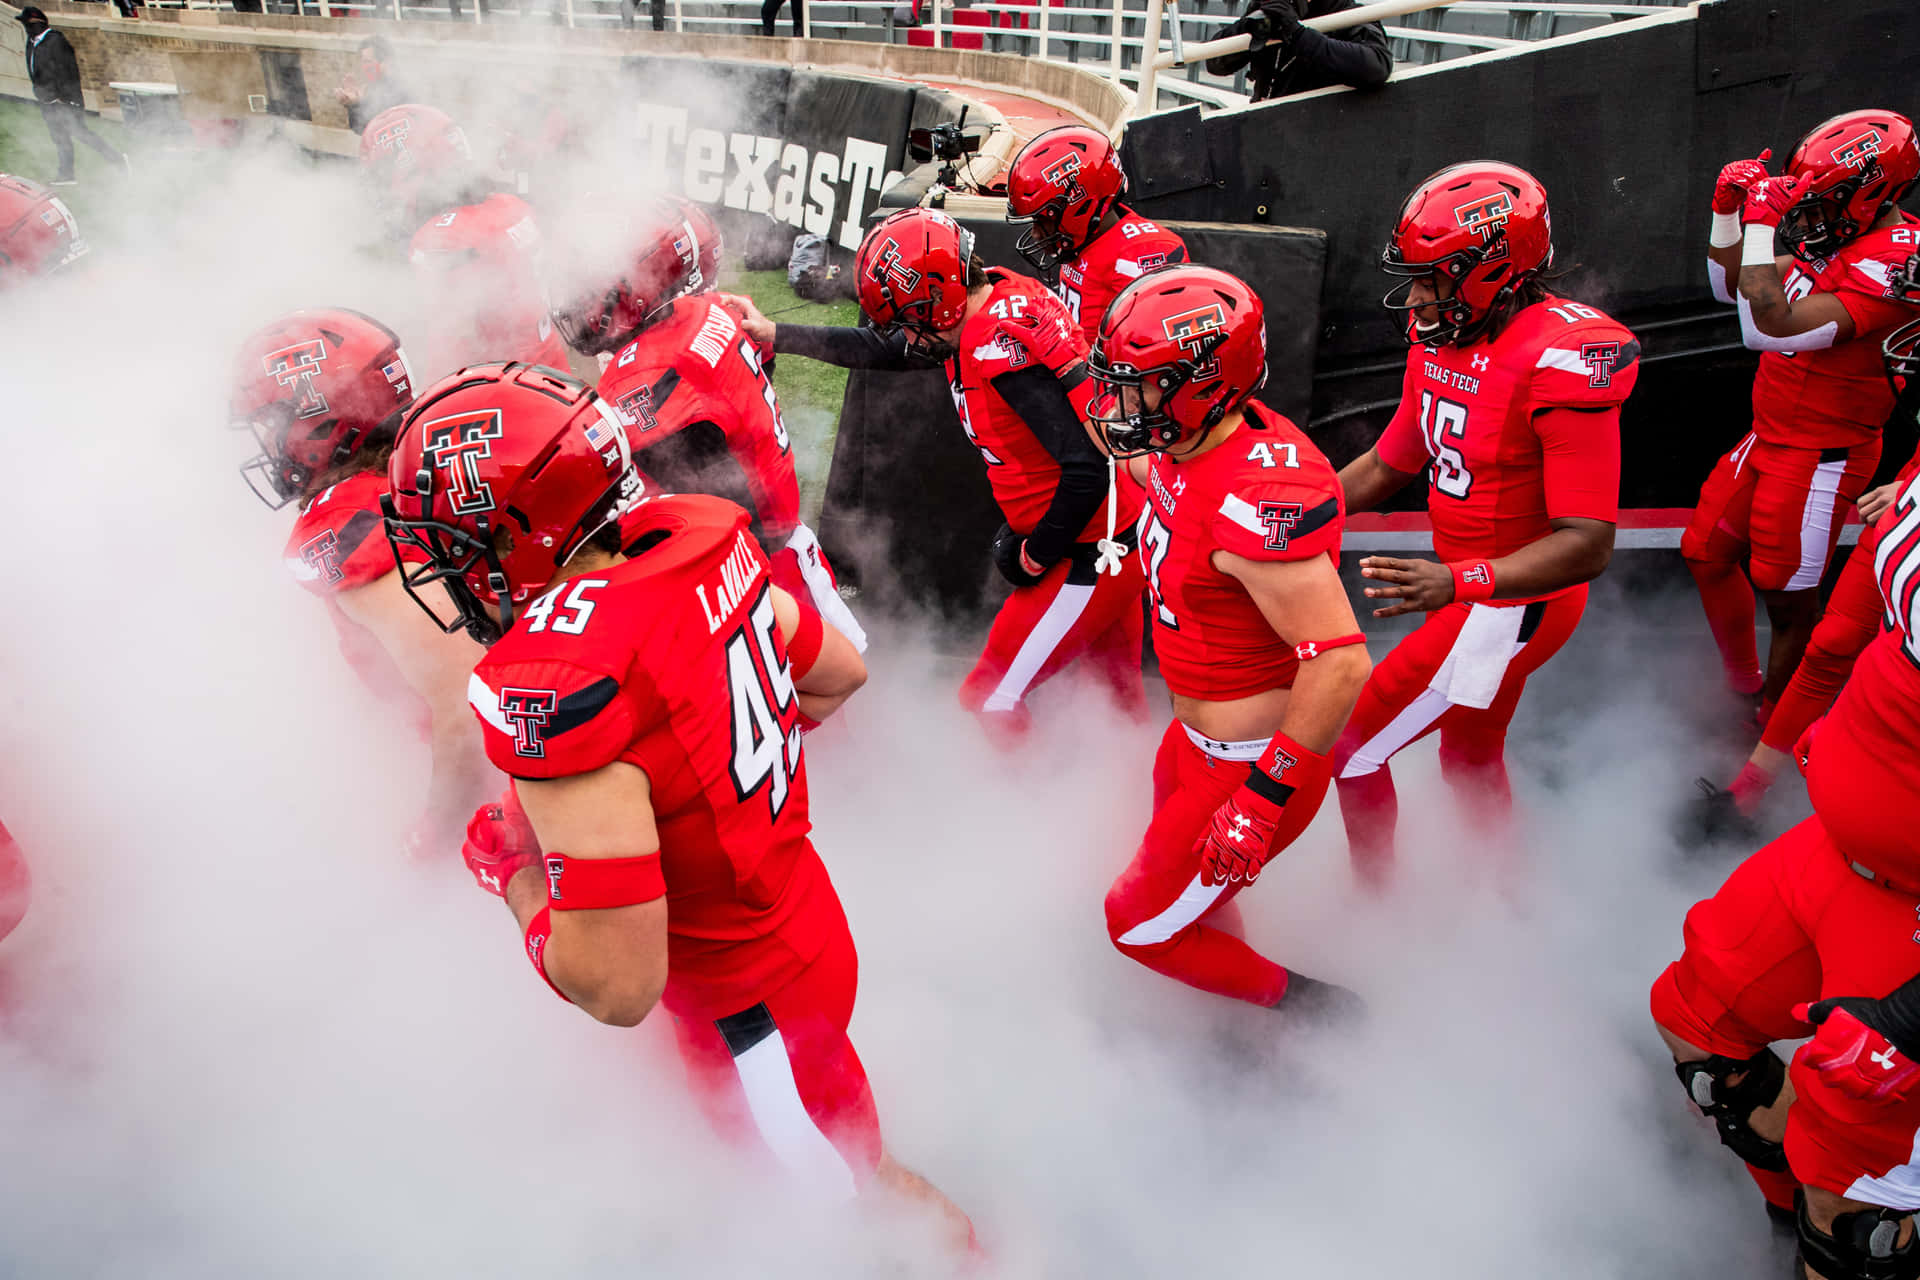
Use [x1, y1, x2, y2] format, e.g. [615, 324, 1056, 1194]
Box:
[947, 267, 1140, 541]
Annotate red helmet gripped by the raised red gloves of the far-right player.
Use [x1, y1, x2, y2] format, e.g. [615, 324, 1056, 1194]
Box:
[1780, 111, 1920, 261]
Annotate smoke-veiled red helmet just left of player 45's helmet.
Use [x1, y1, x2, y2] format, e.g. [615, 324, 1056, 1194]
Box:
[230, 307, 415, 509]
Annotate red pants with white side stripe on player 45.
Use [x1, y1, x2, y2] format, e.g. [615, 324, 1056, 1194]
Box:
[674, 927, 881, 1197]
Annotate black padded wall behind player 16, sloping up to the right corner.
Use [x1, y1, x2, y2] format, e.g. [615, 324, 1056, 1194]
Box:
[1121, 0, 1920, 507]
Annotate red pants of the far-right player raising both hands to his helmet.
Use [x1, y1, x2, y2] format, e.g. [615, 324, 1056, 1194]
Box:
[1680, 432, 1880, 591]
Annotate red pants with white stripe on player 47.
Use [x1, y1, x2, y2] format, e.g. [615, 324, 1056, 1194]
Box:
[1106, 720, 1327, 1006]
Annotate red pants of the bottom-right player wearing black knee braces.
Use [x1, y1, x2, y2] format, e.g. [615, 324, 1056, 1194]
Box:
[1653, 818, 1920, 1207]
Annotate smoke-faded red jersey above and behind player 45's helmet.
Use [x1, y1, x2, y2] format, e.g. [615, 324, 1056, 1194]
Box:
[409, 192, 566, 380]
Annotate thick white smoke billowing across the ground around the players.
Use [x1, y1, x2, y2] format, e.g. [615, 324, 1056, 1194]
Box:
[0, 115, 1797, 1280]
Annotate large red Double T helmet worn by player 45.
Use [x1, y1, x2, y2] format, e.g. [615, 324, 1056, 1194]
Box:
[380, 365, 641, 645]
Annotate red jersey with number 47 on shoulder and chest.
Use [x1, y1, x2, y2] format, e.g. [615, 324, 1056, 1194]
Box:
[1140, 403, 1346, 702]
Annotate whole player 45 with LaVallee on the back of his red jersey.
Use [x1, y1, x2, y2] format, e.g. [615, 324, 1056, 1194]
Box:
[386, 365, 968, 1238]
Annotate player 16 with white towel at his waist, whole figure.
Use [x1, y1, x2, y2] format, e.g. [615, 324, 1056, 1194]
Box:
[1334, 161, 1640, 887]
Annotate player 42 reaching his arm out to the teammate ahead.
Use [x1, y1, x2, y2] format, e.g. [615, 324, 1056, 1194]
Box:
[728, 209, 1146, 743]
